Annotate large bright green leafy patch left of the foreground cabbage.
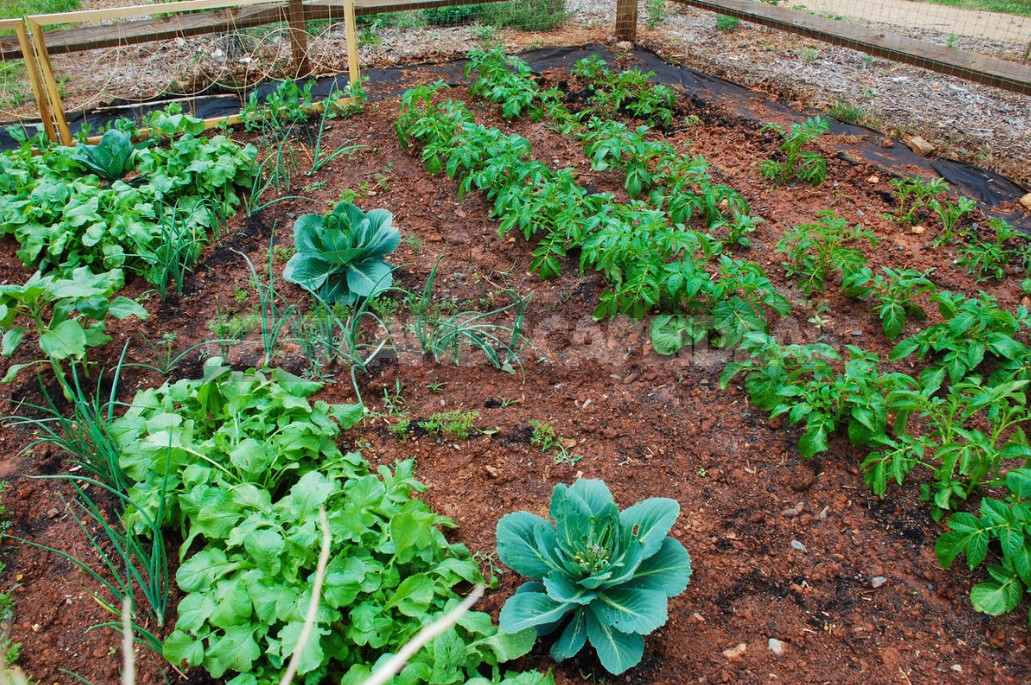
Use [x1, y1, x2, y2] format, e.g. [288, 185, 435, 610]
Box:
[111, 359, 546, 685]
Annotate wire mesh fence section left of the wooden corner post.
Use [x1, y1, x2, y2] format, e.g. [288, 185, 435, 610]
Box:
[0, 0, 570, 126]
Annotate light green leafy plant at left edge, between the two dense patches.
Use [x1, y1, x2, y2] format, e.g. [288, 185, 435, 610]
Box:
[0, 266, 147, 400]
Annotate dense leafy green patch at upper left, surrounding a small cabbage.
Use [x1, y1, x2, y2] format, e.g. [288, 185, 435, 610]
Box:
[0, 113, 258, 279]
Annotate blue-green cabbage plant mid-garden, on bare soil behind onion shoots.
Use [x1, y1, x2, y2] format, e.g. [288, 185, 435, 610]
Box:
[282, 202, 401, 306]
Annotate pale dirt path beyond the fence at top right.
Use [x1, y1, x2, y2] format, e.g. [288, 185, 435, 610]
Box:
[788, 0, 1031, 44]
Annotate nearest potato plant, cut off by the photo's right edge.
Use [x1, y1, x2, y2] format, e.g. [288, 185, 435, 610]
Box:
[934, 467, 1031, 623]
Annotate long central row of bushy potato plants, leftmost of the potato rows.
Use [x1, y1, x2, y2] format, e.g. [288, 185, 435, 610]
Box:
[398, 84, 789, 346]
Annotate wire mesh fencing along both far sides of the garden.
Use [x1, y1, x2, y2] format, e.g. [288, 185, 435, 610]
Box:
[0, 0, 1031, 184]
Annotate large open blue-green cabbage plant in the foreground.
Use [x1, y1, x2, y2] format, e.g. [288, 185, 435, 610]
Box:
[497, 480, 691, 675]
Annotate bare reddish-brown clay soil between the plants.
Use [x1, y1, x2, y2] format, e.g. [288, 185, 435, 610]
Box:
[0, 56, 1031, 685]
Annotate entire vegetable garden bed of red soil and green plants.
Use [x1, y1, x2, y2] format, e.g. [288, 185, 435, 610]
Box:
[0, 38, 1031, 685]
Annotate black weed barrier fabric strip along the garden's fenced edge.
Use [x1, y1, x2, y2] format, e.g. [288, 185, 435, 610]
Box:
[0, 45, 1031, 235]
